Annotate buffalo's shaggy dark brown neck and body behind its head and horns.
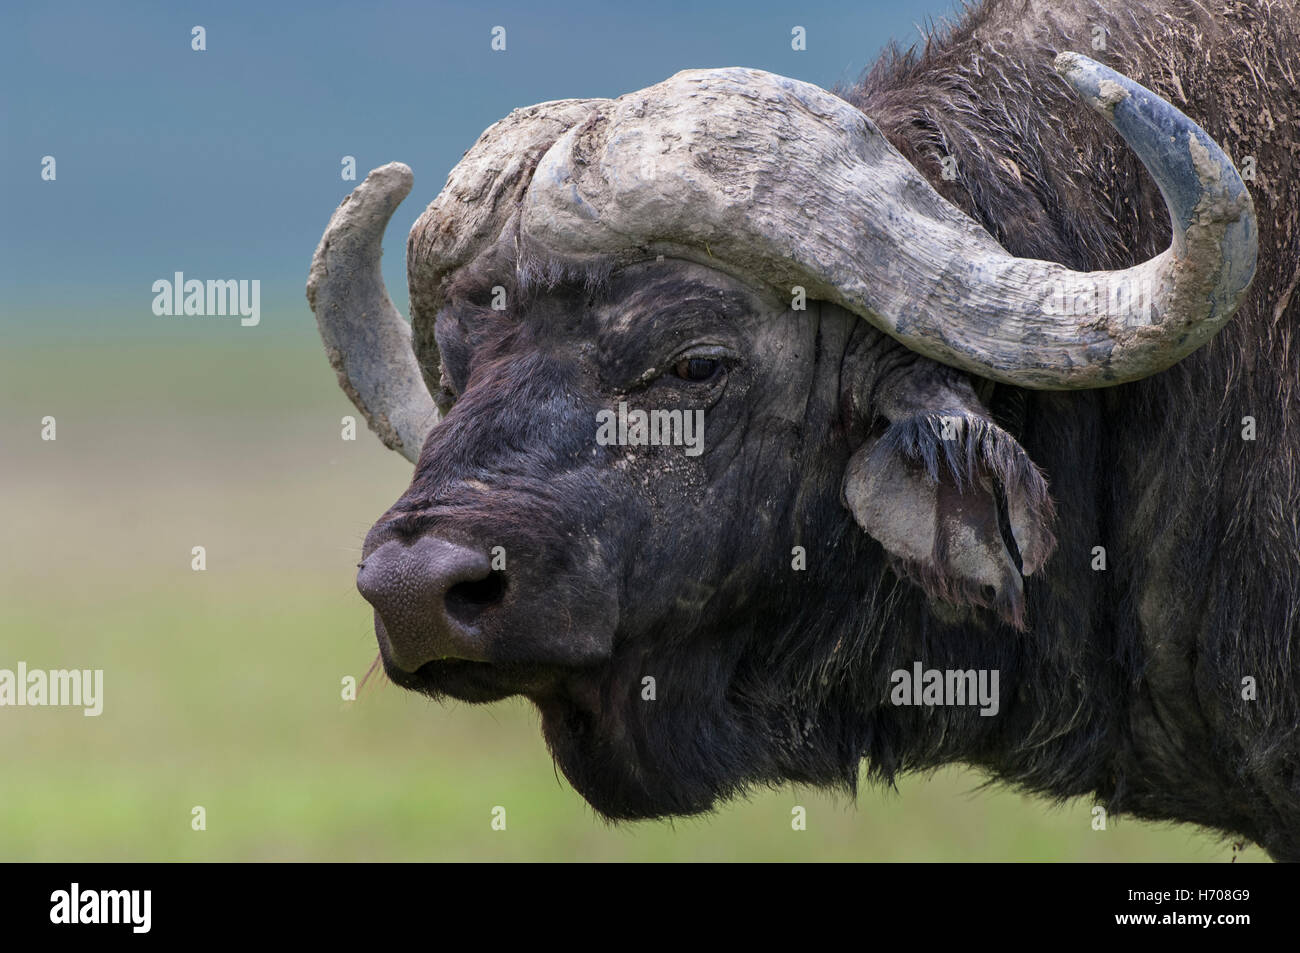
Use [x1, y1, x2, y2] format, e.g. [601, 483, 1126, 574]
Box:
[839, 0, 1300, 859]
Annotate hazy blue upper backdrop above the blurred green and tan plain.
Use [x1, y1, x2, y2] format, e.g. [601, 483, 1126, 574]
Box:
[0, 0, 954, 334]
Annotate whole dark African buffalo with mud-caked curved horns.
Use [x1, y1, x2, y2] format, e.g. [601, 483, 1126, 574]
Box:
[308, 0, 1300, 859]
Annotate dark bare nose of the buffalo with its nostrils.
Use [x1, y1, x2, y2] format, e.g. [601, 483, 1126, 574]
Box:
[356, 536, 506, 672]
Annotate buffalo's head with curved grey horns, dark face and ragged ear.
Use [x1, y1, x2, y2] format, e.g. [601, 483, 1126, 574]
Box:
[308, 55, 1256, 818]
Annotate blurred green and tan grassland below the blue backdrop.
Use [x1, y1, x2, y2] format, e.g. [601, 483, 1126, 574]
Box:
[0, 321, 1266, 862]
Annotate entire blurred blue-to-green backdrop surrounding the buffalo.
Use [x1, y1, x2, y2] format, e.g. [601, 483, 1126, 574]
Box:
[0, 0, 1265, 862]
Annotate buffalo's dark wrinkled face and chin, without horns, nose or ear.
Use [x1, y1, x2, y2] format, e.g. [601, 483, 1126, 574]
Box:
[364, 261, 1024, 818]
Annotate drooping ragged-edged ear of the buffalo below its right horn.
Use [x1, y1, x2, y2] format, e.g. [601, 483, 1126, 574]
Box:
[844, 412, 1056, 629]
